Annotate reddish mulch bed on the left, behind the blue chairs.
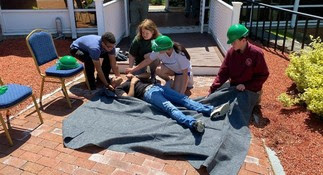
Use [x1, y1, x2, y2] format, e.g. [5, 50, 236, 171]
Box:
[0, 38, 73, 115]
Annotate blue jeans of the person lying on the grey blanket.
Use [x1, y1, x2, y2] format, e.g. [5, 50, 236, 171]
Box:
[144, 85, 213, 128]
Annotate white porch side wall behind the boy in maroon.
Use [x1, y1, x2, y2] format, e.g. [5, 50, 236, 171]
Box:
[208, 0, 242, 54]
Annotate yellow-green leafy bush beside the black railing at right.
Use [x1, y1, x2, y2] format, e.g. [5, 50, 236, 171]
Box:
[278, 36, 323, 117]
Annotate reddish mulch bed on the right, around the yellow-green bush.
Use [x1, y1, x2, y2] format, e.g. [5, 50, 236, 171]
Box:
[250, 45, 323, 174]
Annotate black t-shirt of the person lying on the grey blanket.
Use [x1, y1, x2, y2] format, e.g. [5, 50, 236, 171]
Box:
[115, 80, 150, 99]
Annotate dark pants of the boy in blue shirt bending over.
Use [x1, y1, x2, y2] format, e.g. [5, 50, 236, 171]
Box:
[70, 49, 111, 90]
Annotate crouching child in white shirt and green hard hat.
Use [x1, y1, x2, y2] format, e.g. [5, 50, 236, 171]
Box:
[126, 35, 193, 94]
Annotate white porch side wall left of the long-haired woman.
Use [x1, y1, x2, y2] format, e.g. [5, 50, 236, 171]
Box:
[103, 0, 126, 43]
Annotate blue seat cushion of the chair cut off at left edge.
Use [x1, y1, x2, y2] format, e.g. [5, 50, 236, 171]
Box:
[0, 84, 32, 109]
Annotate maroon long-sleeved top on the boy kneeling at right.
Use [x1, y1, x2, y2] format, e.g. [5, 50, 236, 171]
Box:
[209, 42, 269, 93]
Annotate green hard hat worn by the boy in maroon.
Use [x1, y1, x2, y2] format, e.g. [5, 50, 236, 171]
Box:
[227, 24, 249, 44]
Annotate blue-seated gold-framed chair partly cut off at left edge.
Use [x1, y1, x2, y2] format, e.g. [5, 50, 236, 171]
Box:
[0, 78, 44, 145]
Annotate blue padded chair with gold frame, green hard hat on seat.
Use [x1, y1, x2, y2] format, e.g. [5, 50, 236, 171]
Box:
[26, 29, 90, 108]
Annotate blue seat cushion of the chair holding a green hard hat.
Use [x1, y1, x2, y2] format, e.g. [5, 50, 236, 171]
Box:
[45, 64, 84, 78]
